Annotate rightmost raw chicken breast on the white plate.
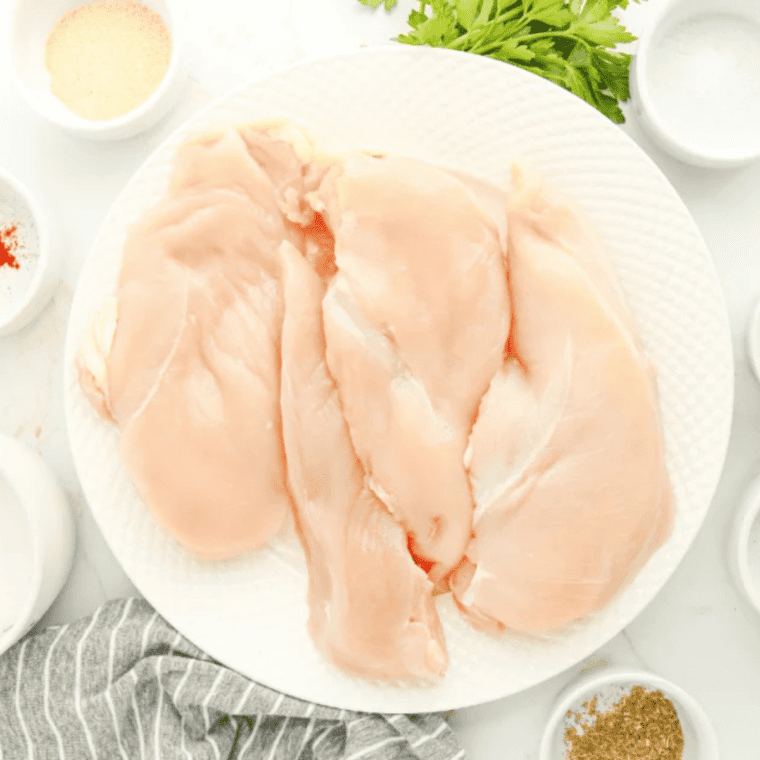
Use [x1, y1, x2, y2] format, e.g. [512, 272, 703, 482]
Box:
[451, 172, 673, 632]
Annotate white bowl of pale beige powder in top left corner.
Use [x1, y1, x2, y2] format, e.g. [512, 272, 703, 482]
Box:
[8, 0, 187, 140]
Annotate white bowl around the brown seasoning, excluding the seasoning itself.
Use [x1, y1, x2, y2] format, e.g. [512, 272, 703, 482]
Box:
[538, 667, 718, 760]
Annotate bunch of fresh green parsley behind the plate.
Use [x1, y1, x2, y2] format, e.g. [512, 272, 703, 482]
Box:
[359, 0, 639, 124]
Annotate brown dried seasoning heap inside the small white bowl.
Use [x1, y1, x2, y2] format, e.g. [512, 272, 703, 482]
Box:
[565, 685, 683, 760]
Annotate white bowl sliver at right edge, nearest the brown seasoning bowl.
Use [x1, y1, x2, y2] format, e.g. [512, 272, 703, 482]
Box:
[729, 475, 760, 613]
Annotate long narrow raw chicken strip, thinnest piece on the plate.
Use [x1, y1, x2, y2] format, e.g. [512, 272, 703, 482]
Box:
[282, 243, 447, 679]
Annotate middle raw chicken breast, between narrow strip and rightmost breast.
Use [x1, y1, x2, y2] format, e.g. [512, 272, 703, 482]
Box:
[322, 155, 509, 580]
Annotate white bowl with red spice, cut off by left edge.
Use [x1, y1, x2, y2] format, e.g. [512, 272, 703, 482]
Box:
[0, 169, 61, 336]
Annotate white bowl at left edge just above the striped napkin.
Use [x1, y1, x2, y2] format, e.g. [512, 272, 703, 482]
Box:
[0, 434, 76, 654]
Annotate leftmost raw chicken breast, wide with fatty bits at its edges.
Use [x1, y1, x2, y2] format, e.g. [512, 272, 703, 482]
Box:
[80, 131, 312, 558]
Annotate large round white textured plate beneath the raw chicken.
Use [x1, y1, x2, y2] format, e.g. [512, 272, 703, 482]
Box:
[65, 46, 733, 712]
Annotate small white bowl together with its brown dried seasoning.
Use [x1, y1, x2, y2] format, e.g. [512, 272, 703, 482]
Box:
[539, 668, 718, 760]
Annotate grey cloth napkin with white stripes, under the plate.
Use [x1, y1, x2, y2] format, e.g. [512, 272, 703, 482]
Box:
[0, 598, 464, 760]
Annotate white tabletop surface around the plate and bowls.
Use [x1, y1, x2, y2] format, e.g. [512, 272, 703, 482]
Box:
[0, 0, 760, 760]
